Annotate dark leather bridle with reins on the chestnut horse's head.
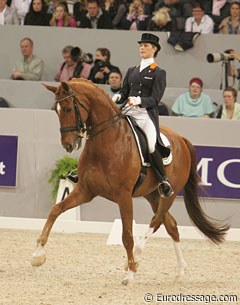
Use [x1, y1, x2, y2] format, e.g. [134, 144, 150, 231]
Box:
[55, 92, 124, 139]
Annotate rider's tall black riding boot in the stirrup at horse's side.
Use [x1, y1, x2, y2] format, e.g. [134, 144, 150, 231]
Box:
[149, 149, 174, 197]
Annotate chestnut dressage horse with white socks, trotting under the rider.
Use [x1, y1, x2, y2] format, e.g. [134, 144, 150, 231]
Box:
[32, 79, 229, 284]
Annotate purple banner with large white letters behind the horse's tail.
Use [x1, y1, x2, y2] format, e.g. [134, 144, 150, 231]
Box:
[194, 146, 240, 199]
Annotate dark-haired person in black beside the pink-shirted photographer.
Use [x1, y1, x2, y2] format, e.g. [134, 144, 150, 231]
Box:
[88, 48, 120, 84]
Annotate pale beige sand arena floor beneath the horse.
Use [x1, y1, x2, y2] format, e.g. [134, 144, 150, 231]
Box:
[0, 229, 240, 305]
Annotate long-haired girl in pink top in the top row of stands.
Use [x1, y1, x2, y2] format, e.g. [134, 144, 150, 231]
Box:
[50, 3, 77, 27]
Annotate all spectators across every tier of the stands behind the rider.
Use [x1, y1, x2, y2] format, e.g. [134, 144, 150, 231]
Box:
[0, 0, 240, 119]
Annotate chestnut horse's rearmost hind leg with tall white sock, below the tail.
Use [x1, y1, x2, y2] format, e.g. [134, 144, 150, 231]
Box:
[164, 213, 187, 278]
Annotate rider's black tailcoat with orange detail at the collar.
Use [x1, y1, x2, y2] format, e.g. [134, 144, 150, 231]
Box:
[119, 63, 169, 157]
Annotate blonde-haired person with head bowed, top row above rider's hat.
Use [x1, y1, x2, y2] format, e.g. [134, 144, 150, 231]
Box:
[147, 7, 177, 32]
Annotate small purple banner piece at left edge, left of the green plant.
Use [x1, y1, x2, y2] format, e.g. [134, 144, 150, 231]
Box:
[0, 136, 18, 187]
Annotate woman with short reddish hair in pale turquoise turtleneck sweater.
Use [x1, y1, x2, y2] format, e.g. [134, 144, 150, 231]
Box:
[172, 77, 214, 118]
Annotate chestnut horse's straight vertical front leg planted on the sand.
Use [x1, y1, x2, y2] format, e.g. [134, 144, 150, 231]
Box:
[118, 194, 137, 285]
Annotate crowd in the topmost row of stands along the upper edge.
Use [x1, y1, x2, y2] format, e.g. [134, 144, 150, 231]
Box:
[0, 0, 240, 34]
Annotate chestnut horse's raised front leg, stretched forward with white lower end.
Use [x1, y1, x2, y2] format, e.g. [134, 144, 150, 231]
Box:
[32, 185, 92, 267]
